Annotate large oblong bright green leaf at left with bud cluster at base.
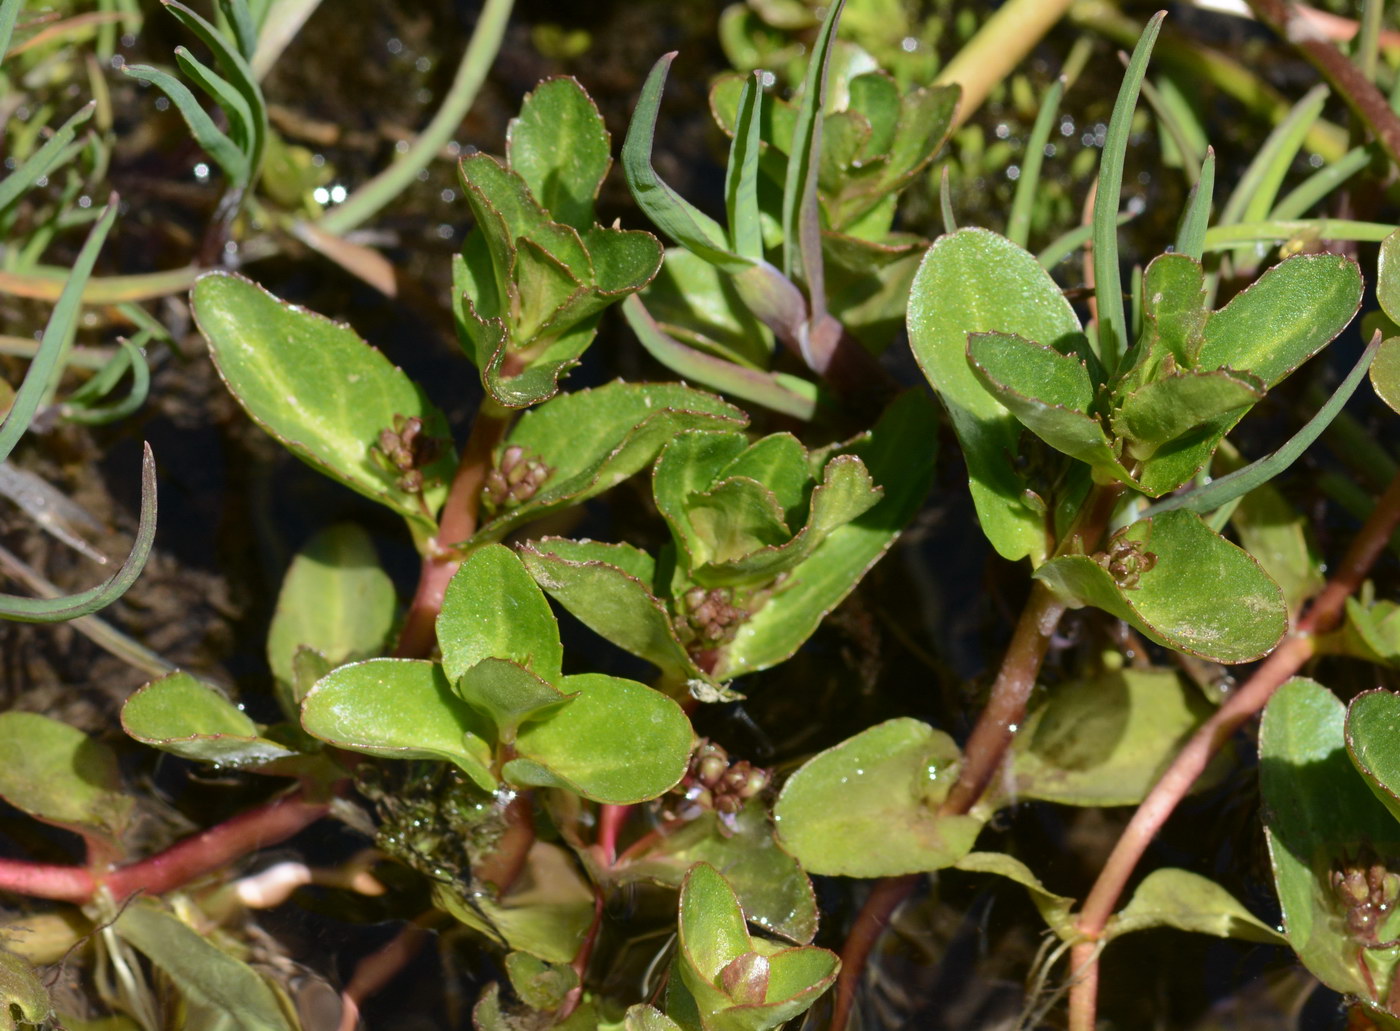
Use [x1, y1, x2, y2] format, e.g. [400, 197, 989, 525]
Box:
[190, 272, 456, 535]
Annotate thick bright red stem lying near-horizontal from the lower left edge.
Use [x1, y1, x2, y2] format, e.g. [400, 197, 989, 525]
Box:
[0, 791, 330, 902]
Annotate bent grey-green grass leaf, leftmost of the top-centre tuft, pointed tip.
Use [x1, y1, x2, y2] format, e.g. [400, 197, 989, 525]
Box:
[622, 50, 752, 273]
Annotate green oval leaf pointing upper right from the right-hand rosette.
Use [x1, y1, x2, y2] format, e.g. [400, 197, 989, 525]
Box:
[1198, 254, 1362, 388]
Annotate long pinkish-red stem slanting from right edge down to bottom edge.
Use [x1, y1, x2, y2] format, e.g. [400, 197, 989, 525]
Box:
[1070, 475, 1400, 1031]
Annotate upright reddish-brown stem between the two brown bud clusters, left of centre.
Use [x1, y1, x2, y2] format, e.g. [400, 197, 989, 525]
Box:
[393, 398, 510, 658]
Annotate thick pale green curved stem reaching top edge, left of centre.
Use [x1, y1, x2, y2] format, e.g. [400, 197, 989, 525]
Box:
[316, 0, 514, 235]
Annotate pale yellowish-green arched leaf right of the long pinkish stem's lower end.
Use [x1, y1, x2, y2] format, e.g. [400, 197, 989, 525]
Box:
[1103, 867, 1287, 946]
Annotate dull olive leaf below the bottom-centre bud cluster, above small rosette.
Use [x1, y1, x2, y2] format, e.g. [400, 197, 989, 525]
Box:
[608, 798, 818, 944]
